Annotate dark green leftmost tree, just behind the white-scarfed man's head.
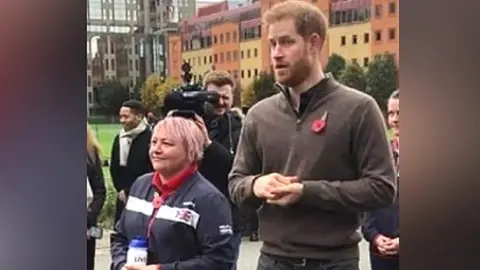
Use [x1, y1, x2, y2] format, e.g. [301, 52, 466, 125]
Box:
[93, 81, 130, 117]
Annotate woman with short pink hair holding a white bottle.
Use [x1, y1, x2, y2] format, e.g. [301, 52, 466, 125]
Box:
[110, 116, 235, 270]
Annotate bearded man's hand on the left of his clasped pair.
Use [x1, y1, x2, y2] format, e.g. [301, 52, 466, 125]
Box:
[253, 173, 297, 199]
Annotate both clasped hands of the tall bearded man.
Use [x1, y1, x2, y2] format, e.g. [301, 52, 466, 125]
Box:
[253, 173, 303, 206]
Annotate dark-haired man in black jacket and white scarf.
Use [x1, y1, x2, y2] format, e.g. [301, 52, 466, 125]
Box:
[110, 100, 153, 223]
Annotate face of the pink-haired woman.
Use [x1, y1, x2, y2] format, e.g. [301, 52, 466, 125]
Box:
[149, 127, 189, 177]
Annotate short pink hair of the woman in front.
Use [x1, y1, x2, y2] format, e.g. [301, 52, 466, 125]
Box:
[154, 117, 205, 163]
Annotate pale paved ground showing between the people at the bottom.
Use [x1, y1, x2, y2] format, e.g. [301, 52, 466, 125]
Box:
[95, 231, 370, 270]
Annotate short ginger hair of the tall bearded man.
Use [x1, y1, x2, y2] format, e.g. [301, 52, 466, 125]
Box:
[263, 0, 327, 42]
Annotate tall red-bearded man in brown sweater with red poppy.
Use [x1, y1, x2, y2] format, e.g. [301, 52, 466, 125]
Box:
[229, 0, 396, 270]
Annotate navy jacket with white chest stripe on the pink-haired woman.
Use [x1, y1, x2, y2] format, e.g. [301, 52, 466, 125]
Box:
[110, 172, 235, 270]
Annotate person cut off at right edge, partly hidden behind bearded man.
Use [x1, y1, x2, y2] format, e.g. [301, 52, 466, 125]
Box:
[362, 90, 400, 270]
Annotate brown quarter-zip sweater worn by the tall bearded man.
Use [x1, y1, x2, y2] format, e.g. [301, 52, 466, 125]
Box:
[229, 78, 396, 260]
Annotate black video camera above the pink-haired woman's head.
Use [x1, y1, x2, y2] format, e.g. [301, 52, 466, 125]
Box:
[163, 62, 220, 120]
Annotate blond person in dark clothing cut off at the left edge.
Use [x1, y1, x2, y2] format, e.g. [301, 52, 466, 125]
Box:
[87, 123, 106, 270]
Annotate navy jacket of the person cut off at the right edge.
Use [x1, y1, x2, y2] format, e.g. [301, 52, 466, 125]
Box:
[362, 144, 400, 251]
